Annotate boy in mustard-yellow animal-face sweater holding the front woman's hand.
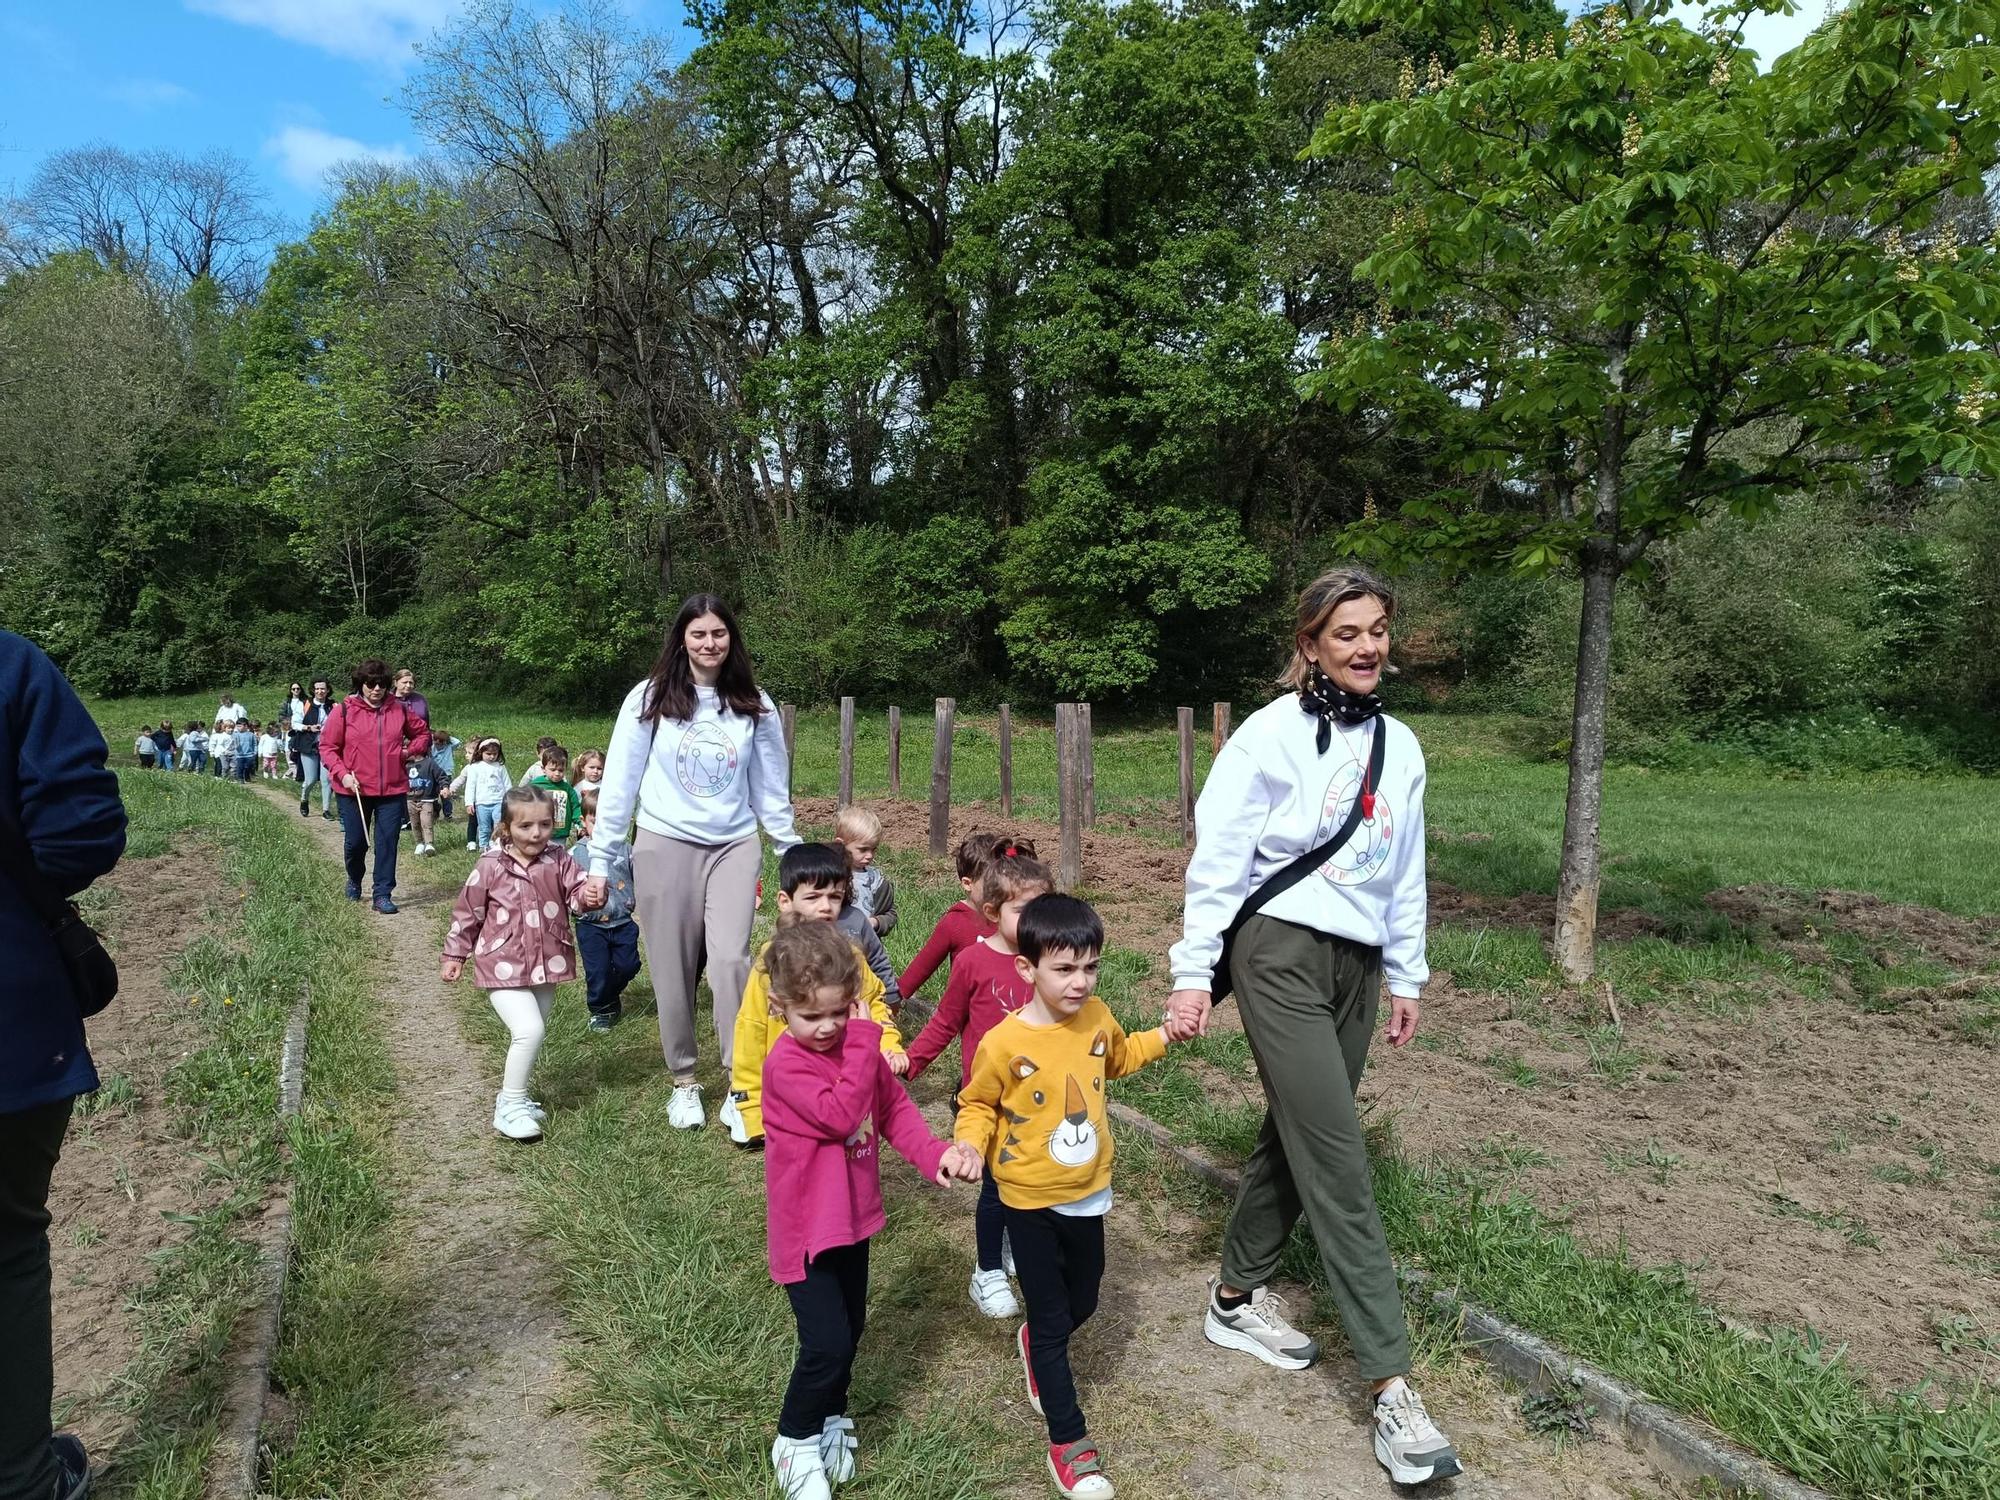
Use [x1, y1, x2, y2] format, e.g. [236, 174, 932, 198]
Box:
[956, 894, 1168, 1500]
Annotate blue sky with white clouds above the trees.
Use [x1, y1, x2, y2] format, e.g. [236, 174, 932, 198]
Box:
[0, 0, 1826, 247]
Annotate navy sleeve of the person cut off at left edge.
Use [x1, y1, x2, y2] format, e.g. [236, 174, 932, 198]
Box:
[0, 632, 126, 896]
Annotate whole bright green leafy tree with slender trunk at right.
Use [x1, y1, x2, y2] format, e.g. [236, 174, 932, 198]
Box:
[1314, 0, 2000, 982]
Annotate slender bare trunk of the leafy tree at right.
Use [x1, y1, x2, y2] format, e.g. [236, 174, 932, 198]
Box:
[1556, 536, 1618, 984]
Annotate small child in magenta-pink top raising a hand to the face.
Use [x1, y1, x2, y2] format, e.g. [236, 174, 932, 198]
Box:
[762, 922, 980, 1500]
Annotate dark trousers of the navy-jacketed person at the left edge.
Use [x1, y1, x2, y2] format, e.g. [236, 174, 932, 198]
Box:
[0, 1100, 74, 1500]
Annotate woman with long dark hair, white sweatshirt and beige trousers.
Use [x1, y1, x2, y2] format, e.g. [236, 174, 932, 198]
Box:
[590, 594, 798, 1130]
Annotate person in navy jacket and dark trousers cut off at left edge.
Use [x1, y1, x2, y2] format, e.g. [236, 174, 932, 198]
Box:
[0, 630, 126, 1500]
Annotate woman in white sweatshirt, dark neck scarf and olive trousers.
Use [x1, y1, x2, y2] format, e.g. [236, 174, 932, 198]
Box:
[1168, 568, 1460, 1484]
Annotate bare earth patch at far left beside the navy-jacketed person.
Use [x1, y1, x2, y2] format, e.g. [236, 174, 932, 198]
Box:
[48, 864, 220, 1458]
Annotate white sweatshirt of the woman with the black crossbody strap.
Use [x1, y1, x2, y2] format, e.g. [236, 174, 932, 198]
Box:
[1168, 694, 1430, 996]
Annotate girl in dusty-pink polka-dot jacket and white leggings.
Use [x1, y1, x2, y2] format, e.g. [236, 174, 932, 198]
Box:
[450, 786, 596, 1140]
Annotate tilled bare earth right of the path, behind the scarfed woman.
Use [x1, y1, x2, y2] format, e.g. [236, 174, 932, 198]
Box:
[828, 802, 2000, 1388]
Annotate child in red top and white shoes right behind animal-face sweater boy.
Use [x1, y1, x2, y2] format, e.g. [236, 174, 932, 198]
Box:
[910, 844, 1056, 1318]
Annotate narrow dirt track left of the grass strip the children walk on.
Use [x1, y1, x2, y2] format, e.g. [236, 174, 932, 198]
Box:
[282, 804, 610, 1500]
